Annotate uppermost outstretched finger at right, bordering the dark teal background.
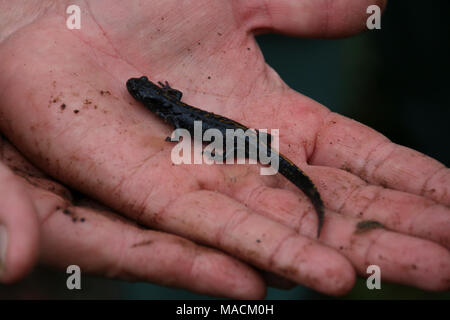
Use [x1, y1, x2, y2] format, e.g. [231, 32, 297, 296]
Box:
[310, 113, 450, 205]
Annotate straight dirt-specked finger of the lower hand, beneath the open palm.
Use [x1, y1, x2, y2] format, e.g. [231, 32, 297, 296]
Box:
[27, 187, 265, 299]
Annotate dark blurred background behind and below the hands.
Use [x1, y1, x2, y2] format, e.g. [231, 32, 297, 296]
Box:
[0, 0, 450, 299]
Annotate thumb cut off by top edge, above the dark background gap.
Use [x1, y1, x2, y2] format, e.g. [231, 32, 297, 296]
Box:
[240, 0, 386, 38]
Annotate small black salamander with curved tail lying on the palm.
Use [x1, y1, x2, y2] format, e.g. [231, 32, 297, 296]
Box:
[127, 76, 324, 237]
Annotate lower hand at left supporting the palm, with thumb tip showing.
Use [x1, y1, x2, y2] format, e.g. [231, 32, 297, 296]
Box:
[0, 136, 264, 298]
